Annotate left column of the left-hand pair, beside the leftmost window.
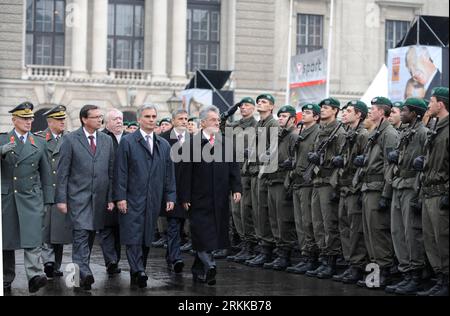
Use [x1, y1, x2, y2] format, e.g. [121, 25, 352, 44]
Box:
[71, 0, 88, 76]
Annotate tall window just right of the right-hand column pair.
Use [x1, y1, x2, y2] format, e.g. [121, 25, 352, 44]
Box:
[187, 0, 220, 71]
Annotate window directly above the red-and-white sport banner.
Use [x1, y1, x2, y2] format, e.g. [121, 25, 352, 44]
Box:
[297, 14, 323, 54]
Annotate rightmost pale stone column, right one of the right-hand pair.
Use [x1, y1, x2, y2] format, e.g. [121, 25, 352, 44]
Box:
[171, 0, 187, 80]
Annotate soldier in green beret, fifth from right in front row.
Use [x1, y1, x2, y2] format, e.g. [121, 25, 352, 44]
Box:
[306, 98, 345, 279]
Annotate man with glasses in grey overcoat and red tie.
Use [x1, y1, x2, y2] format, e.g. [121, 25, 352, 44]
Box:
[56, 105, 114, 291]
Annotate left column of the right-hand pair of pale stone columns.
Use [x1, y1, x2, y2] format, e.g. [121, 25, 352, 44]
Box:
[152, 0, 167, 81]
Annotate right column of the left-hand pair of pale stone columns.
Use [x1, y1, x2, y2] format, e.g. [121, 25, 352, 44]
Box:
[92, 0, 108, 77]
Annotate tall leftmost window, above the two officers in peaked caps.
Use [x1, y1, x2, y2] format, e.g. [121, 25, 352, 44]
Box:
[25, 0, 66, 66]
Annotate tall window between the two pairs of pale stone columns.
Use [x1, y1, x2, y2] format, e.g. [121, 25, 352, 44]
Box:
[108, 0, 145, 69]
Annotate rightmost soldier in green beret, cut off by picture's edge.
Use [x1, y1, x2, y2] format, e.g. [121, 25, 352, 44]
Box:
[414, 87, 449, 296]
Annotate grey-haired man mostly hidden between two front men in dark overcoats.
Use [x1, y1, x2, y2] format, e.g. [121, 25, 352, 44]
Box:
[161, 110, 192, 273]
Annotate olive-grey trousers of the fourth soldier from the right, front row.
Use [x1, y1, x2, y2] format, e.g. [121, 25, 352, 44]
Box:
[339, 193, 369, 268]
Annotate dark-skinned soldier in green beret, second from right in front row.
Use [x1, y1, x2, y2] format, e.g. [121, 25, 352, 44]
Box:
[386, 98, 428, 295]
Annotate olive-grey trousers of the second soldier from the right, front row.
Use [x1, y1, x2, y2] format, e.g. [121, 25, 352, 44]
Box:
[391, 189, 425, 273]
